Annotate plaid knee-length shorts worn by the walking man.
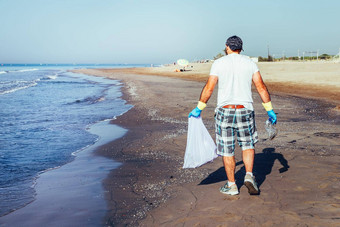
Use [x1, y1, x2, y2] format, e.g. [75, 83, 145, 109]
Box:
[215, 107, 258, 156]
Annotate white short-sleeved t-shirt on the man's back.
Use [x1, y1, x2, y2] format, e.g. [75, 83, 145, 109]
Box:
[210, 54, 259, 110]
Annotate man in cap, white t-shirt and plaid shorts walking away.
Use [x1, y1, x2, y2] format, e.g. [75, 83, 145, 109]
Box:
[189, 36, 277, 195]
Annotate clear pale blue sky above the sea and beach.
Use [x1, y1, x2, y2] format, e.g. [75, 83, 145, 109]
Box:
[0, 0, 340, 63]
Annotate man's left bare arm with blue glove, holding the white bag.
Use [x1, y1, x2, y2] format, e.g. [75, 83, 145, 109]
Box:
[189, 76, 218, 118]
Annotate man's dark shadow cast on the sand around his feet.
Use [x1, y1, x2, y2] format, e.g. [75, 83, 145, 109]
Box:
[198, 148, 289, 191]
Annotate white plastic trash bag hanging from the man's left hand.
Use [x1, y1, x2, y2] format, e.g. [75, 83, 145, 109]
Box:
[183, 117, 217, 168]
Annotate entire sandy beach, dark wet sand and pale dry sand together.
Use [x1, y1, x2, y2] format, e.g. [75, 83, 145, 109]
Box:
[72, 62, 340, 226]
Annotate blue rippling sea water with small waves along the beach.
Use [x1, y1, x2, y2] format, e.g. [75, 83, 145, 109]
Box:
[0, 65, 147, 217]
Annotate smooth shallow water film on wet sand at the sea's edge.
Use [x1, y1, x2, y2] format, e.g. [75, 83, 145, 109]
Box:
[0, 121, 126, 226]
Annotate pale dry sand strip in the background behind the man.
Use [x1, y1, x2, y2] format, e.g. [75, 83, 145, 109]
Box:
[104, 61, 340, 104]
